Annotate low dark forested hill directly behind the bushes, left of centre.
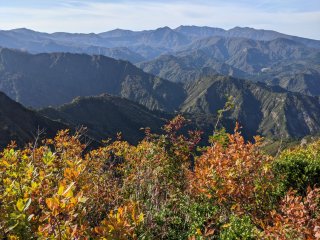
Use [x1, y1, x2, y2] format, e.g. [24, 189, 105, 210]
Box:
[39, 94, 169, 143]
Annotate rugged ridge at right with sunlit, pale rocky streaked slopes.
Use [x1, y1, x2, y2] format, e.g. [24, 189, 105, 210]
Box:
[181, 76, 320, 138]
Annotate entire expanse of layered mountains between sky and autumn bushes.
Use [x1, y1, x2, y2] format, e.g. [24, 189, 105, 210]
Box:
[0, 26, 320, 146]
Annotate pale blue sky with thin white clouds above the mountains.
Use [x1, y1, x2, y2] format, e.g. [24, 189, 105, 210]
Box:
[0, 0, 320, 40]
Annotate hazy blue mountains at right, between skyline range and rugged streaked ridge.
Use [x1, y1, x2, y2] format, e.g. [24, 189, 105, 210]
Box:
[137, 37, 320, 95]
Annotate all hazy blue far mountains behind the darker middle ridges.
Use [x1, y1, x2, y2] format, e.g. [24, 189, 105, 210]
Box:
[0, 26, 320, 95]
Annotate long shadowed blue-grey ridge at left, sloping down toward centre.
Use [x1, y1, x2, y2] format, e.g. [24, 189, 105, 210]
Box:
[0, 49, 185, 111]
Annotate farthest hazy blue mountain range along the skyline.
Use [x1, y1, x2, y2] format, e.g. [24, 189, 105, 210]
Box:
[0, 26, 320, 62]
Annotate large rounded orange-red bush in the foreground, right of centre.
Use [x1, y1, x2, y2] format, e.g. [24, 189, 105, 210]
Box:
[189, 126, 276, 218]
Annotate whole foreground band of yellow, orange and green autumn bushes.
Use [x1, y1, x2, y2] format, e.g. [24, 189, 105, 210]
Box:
[0, 116, 320, 239]
